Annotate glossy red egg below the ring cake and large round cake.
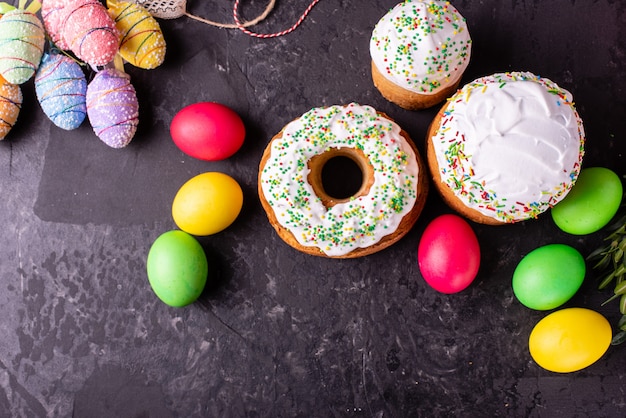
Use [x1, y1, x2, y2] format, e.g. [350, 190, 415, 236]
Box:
[417, 214, 480, 293]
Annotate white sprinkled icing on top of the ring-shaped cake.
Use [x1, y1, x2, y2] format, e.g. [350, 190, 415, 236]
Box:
[260, 103, 418, 256]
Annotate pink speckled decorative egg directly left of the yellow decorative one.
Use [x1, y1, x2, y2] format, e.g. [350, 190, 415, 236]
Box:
[59, 0, 119, 66]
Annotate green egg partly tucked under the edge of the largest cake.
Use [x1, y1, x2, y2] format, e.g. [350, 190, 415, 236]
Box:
[552, 167, 623, 235]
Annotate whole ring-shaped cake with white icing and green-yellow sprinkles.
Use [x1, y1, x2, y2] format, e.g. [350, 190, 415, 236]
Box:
[258, 103, 428, 258]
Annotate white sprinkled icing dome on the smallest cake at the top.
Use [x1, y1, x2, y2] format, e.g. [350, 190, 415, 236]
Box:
[370, 0, 471, 94]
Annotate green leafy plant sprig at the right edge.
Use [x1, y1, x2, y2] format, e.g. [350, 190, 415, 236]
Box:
[587, 211, 626, 345]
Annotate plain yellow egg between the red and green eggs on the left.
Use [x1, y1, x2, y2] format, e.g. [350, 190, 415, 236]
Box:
[172, 172, 243, 236]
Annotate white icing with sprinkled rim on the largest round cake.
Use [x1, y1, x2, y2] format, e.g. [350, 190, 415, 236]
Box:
[433, 73, 584, 222]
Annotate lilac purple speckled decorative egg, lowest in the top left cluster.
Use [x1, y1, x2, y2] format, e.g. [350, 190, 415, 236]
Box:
[87, 68, 139, 148]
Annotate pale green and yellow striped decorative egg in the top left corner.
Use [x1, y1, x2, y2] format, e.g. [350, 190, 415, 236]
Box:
[0, 9, 45, 84]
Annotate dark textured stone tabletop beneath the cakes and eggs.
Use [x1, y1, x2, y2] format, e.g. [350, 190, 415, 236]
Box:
[0, 0, 626, 417]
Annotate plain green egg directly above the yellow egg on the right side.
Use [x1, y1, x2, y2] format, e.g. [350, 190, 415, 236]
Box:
[513, 244, 586, 311]
